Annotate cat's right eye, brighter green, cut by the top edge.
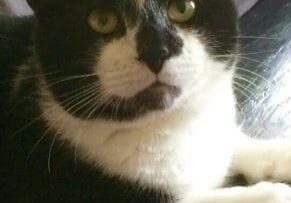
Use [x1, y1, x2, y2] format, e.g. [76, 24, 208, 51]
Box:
[168, 0, 195, 23]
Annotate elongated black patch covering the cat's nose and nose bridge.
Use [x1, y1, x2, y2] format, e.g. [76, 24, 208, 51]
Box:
[136, 12, 183, 74]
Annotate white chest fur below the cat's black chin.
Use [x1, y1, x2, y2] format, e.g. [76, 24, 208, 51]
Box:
[41, 72, 240, 197]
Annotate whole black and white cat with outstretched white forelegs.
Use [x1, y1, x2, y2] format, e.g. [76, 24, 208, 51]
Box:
[0, 0, 291, 203]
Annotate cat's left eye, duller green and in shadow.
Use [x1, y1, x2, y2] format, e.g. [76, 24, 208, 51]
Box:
[88, 10, 118, 34]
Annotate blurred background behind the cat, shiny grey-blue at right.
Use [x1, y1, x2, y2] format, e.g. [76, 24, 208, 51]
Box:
[0, 0, 291, 138]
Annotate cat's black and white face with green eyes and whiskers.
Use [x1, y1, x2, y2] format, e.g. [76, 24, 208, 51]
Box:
[30, 0, 237, 120]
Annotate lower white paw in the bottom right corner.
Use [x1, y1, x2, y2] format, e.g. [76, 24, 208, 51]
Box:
[253, 182, 291, 203]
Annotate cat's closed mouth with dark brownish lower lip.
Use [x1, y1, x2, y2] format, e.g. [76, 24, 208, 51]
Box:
[135, 81, 181, 110]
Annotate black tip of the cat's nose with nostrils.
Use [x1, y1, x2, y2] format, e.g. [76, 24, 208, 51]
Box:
[138, 46, 170, 74]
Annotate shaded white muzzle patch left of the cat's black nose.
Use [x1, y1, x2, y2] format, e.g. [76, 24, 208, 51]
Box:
[95, 30, 156, 98]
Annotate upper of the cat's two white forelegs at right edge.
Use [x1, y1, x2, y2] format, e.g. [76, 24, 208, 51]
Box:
[239, 141, 291, 183]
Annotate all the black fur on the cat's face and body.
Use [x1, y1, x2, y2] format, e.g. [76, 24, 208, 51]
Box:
[0, 0, 240, 203]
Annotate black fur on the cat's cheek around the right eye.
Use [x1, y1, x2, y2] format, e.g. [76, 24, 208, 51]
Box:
[187, 0, 238, 56]
